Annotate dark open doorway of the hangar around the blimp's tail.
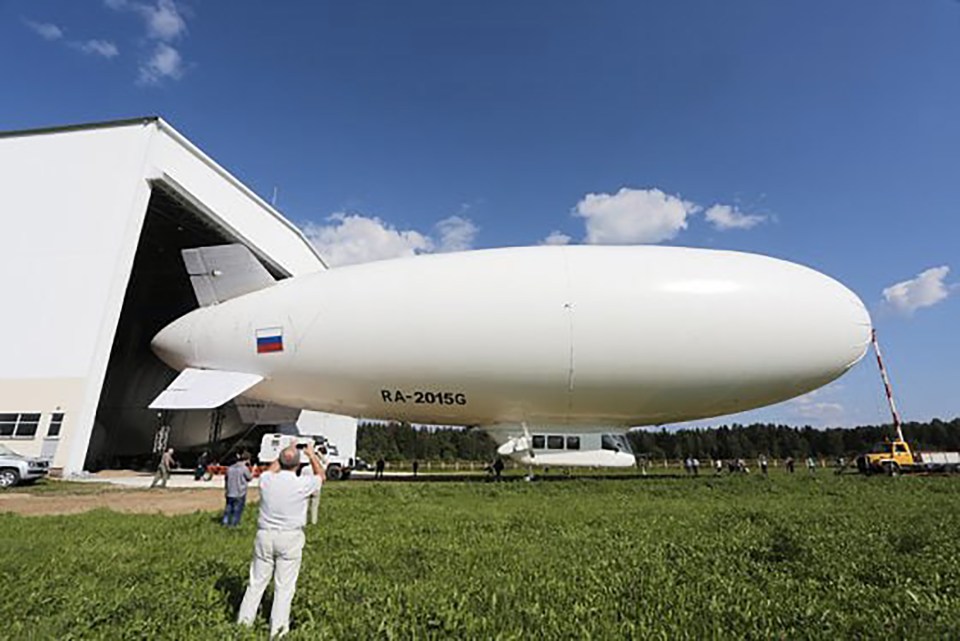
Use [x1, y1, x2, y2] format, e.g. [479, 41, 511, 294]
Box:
[84, 183, 283, 470]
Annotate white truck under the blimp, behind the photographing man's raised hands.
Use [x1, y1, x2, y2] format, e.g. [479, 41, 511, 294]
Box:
[257, 410, 357, 481]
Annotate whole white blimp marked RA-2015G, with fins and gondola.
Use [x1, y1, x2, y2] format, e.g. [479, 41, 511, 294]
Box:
[151, 245, 871, 465]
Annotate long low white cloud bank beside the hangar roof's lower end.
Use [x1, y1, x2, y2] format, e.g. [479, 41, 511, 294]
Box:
[303, 212, 479, 267]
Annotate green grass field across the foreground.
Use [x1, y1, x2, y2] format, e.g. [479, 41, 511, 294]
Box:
[0, 474, 960, 639]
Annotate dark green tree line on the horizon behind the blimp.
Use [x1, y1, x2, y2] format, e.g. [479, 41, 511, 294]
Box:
[357, 417, 960, 461]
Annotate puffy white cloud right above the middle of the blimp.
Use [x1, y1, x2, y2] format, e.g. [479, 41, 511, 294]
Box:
[574, 187, 700, 245]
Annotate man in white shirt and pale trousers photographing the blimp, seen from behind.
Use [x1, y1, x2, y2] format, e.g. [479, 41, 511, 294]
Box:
[237, 443, 326, 636]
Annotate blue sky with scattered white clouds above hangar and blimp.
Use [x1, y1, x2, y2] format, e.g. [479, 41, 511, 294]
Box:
[0, 0, 960, 425]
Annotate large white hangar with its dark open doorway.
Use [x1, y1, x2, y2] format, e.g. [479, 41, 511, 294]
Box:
[0, 117, 326, 475]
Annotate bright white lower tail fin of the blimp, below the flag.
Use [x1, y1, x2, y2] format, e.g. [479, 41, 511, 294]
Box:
[149, 367, 263, 410]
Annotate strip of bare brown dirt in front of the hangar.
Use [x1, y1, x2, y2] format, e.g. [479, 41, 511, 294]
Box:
[0, 488, 259, 516]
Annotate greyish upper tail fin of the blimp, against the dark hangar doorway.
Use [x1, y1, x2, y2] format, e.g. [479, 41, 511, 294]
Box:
[180, 243, 276, 307]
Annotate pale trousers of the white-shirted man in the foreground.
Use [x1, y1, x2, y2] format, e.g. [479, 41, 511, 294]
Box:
[237, 530, 305, 636]
